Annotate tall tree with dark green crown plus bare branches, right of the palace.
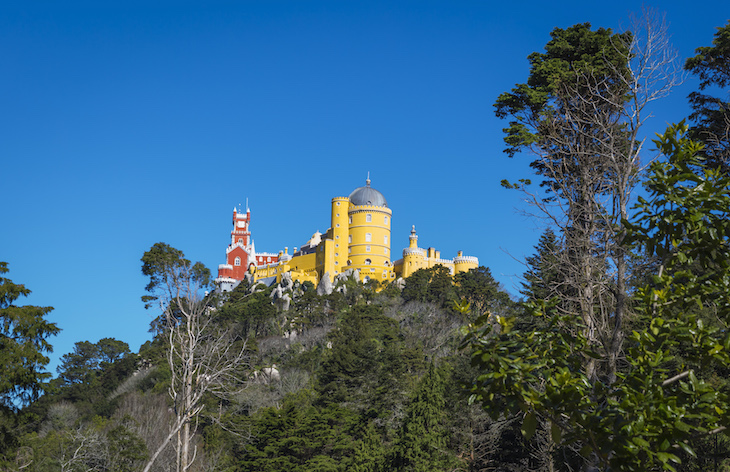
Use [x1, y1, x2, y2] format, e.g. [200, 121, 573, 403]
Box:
[495, 12, 679, 379]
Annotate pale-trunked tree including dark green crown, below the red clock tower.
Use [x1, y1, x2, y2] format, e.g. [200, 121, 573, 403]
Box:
[142, 243, 246, 472]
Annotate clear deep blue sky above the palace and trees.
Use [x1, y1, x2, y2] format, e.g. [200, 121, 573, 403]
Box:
[0, 0, 730, 373]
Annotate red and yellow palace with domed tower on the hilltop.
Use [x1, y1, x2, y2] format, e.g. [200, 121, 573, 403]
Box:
[215, 179, 479, 292]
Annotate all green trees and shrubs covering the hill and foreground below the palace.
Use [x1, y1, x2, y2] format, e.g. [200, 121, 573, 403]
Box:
[0, 14, 730, 472]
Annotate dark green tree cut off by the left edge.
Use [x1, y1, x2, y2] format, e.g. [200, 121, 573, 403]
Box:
[0, 262, 60, 454]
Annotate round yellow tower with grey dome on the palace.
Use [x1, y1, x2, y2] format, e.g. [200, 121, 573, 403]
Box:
[347, 179, 393, 282]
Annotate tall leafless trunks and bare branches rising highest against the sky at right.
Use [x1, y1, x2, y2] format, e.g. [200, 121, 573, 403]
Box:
[516, 7, 682, 383]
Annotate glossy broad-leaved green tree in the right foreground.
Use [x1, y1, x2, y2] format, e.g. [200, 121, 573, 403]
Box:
[464, 125, 730, 471]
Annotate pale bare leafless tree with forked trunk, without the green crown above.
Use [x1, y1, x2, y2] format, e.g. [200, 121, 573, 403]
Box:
[144, 267, 246, 472]
